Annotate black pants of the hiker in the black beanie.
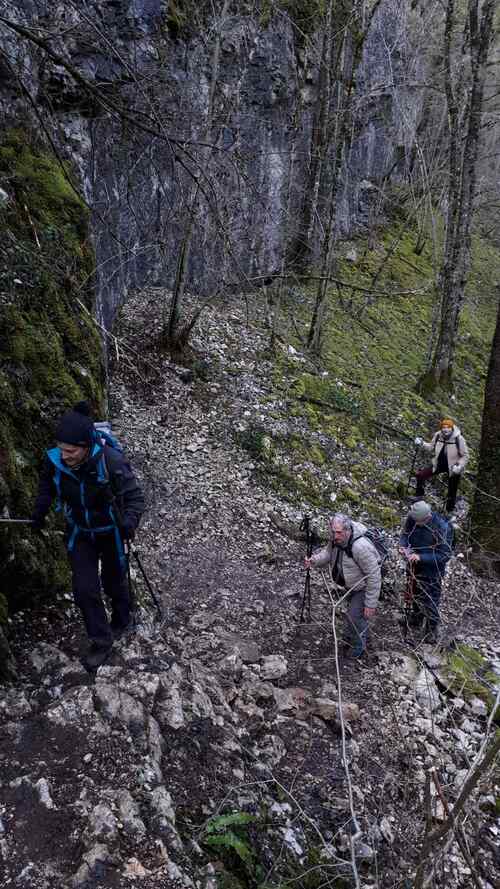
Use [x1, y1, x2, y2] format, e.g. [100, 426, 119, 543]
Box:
[68, 533, 130, 646]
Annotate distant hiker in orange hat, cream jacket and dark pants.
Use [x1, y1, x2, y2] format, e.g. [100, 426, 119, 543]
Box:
[415, 417, 469, 512]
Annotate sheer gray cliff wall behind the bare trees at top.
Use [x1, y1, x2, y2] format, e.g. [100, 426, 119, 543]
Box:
[0, 0, 421, 326]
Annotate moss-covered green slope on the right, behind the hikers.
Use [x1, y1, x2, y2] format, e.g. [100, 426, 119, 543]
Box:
[240, 218, 500, 526]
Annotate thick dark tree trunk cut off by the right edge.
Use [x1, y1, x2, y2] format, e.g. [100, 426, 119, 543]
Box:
[471, 286, 500, 579]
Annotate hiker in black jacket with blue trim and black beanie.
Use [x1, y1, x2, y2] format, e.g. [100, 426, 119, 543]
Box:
[32, 402, 144, 670]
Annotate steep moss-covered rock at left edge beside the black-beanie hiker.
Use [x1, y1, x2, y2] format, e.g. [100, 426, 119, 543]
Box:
[0, 130, 104, 664]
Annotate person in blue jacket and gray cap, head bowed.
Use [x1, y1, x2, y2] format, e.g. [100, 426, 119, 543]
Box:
[399, 500, 453, 644]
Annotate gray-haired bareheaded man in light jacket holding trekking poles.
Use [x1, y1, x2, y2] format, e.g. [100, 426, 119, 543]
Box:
[306, 512, 382, 658]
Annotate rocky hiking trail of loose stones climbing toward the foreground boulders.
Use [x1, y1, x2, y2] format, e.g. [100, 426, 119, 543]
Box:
[0, 291, 500, 889]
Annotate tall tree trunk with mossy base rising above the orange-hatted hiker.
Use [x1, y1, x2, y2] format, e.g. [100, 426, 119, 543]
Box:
[419, 0, 495, 392]
